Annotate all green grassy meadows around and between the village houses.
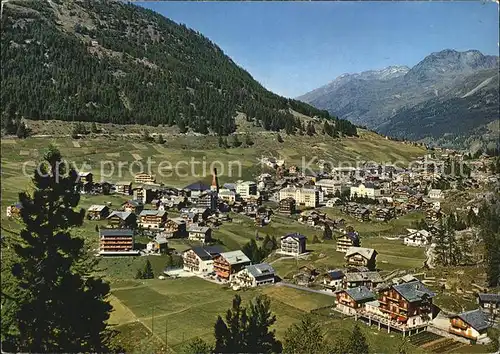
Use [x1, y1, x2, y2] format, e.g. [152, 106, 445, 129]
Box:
[1, 128, 436, 353]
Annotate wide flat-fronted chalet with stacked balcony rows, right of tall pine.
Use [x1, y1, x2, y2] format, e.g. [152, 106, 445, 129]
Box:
[99, 229, 139, 256]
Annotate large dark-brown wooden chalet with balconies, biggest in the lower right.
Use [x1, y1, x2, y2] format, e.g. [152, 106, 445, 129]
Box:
[378, 280, 436, 327]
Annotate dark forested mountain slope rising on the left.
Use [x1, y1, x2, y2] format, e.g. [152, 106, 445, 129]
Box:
[0, 0, 356, 135]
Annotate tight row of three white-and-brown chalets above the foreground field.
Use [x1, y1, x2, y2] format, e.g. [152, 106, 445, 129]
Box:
[182, 246, 275, 288]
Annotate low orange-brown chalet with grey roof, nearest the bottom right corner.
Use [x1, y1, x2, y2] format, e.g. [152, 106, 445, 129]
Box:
[448, 309, 490, 343]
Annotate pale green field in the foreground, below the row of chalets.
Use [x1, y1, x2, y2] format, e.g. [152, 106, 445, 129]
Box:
[106, 278, 421, 353]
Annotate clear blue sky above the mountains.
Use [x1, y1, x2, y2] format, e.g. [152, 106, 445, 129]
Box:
[140, 1, 498, 97]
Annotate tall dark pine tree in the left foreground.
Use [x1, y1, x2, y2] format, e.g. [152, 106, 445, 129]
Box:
[2, 147, 112, 353]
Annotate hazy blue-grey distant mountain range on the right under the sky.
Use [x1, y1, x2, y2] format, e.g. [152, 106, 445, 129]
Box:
[298, 49, 499, 145]
